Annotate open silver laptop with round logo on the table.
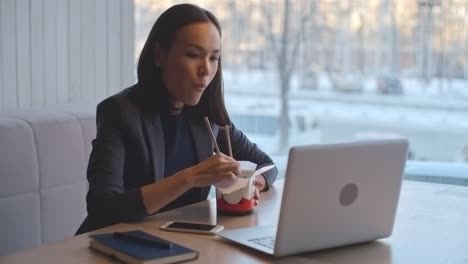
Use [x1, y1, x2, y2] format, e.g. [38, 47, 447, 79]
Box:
[218, 139, 408, 256]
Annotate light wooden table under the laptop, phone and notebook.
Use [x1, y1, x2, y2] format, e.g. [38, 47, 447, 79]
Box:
[0, 180, 468, 264]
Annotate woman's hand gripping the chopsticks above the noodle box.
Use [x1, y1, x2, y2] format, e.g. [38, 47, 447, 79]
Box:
[180, 153, 240, 187]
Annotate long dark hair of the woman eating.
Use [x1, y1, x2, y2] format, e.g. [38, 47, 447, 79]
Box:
[137, 4, 230, 125]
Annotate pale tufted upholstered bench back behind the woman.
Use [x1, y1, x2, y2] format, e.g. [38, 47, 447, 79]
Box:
[0, 105, 96, 255]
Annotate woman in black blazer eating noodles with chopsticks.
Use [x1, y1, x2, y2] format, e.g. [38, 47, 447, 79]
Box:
[77, 4, 277, 234]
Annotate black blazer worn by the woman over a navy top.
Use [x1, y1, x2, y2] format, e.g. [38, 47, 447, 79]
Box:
[77, 84, 278, 234]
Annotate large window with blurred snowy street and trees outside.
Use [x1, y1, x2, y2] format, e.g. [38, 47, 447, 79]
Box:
[135, 0, 468, 184]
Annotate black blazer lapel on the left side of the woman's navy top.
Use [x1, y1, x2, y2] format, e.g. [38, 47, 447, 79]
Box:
[143, 111, 165, 181]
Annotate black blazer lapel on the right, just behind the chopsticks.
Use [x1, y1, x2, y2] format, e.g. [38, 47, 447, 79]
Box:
[189, 116, 219, 162]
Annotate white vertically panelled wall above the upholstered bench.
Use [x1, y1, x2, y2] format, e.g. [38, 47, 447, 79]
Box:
[0, 0, 135, 111]
